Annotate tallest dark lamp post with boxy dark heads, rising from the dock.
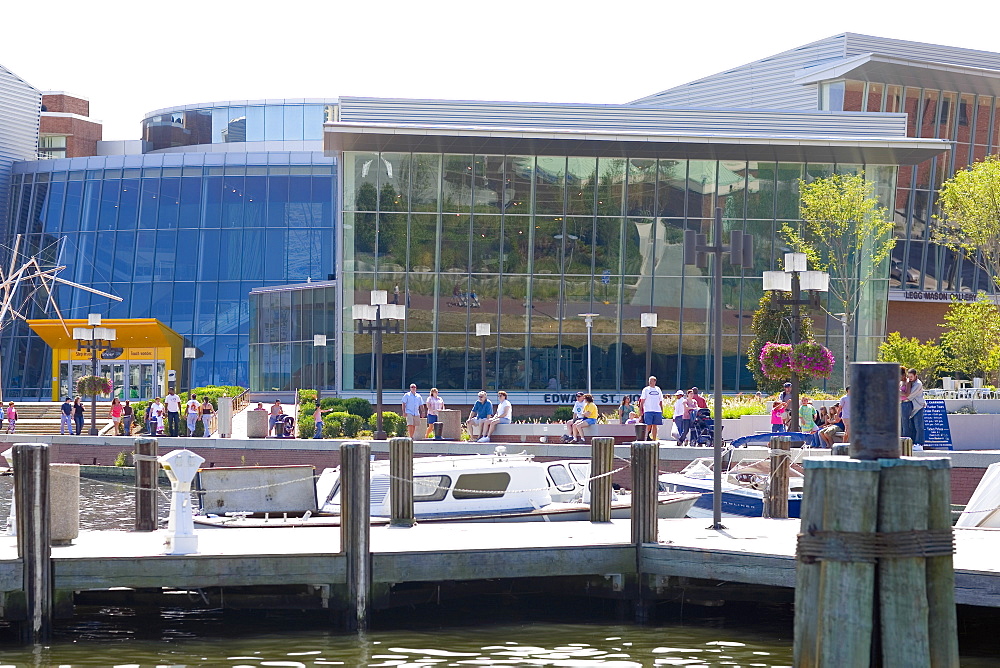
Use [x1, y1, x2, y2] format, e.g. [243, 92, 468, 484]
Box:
[684, 207, 753, 529]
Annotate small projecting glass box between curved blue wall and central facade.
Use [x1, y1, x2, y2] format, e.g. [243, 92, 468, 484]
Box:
[250, 281, 337, 391]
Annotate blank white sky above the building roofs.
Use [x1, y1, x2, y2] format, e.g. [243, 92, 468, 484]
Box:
[0, 0, 1000, 139]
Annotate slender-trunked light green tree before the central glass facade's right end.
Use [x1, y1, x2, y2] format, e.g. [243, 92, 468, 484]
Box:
[781, 172, 896, 364]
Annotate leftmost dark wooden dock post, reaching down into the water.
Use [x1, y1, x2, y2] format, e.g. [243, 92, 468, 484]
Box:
[14, 443, 52, 644]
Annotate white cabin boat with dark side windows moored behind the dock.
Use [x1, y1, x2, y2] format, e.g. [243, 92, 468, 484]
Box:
[195, 453, 700, 527]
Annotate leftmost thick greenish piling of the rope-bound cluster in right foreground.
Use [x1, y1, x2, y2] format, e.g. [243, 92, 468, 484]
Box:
[794, 460, 879, 668]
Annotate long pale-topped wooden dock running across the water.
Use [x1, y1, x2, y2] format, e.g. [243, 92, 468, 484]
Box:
[0, 518, 1000, 619]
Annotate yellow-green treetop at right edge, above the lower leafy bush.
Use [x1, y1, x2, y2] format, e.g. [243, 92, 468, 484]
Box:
[931, 155, 1000, 287]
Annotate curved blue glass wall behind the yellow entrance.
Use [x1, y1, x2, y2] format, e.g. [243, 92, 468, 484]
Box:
[0, 152, 336, 400]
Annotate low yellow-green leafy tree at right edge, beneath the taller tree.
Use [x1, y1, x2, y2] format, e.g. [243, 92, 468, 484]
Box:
[941, 292, 1000, 378]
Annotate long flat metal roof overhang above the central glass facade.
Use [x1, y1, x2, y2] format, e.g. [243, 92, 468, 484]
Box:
[324, 123, 951, 165]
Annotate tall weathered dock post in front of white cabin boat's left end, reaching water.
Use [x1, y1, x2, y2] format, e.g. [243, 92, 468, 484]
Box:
[340, 442, 371, 631]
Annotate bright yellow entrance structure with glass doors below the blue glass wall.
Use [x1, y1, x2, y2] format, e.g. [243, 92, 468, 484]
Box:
[28, 318, 184, 401]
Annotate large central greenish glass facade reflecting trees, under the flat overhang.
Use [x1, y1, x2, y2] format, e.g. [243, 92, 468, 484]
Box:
[340, 152, 896, 392]
